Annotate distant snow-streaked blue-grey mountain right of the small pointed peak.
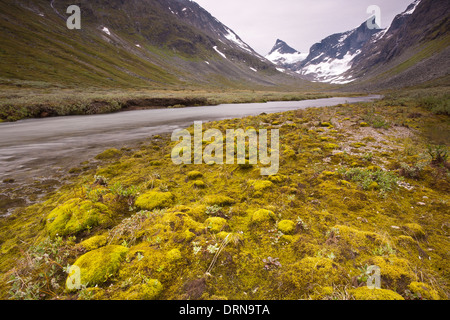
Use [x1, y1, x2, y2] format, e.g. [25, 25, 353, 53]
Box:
[291, 22, 383, 83]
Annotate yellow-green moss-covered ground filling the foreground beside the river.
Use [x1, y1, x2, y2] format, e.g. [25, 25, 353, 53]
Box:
[0, 95, 450, 300]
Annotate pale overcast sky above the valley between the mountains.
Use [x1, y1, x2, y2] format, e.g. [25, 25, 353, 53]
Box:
[195, 0, 413, 55]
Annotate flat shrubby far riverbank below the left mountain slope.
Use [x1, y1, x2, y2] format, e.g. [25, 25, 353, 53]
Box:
[0, 87, 361, 121]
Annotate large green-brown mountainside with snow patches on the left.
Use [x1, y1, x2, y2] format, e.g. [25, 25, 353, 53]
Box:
[0, 0, 306, 89]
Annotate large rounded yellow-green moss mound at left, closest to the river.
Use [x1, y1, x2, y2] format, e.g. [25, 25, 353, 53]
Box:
[46, 199, 112, 237]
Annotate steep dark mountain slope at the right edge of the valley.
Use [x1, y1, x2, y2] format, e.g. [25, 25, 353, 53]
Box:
[346, 0, 450, 90]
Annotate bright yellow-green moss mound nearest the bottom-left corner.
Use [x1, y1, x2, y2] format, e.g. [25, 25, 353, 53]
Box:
[66, 246, 128, 289]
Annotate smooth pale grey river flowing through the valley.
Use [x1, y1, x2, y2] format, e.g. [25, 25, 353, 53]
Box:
[0, 96, 380, 216]
